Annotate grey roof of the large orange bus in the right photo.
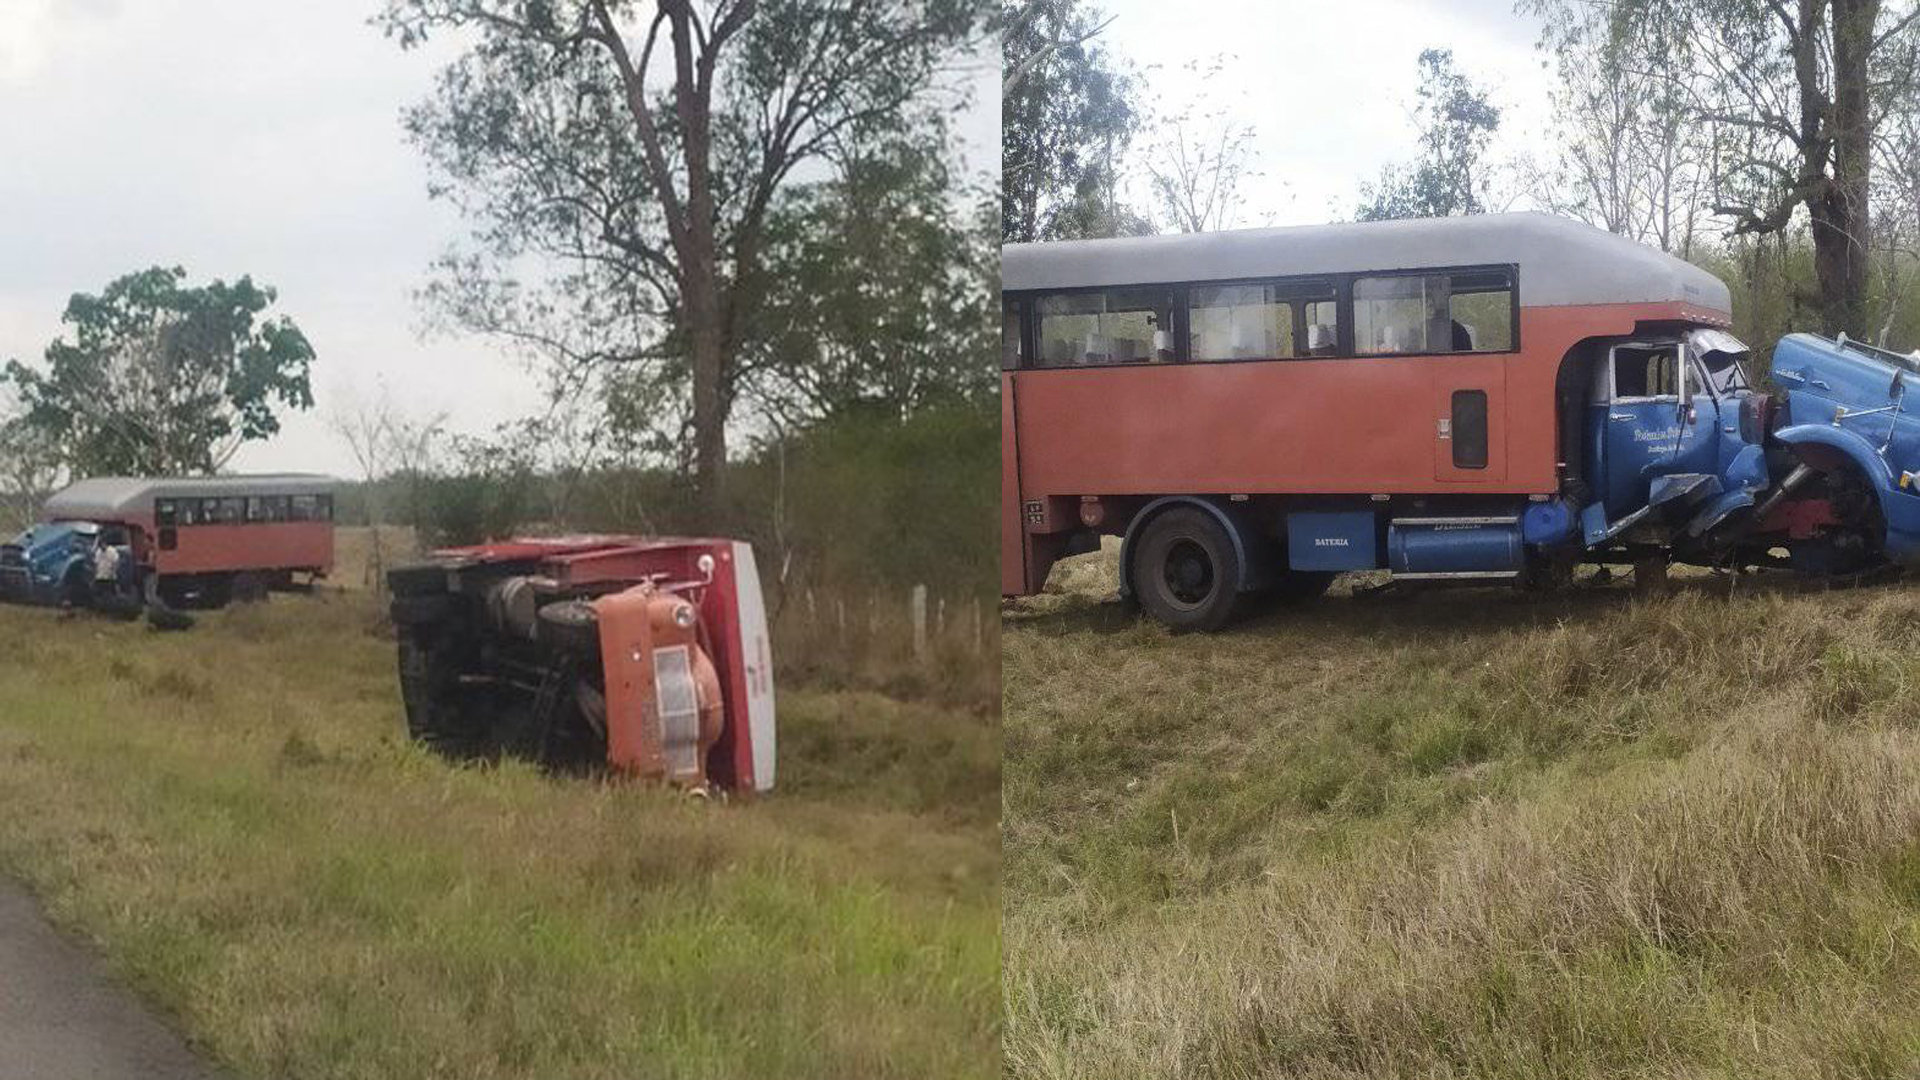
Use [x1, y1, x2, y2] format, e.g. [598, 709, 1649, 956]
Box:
[1000, 213, 1732, 311]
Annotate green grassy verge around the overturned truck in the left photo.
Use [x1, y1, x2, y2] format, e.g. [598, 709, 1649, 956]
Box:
[0, 592, 1000, 1080]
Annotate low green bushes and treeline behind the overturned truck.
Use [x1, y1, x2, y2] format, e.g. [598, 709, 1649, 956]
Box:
[336, 404, 1000, 603]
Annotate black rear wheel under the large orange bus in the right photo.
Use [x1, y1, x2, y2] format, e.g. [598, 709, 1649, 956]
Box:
[1127, 507, 1240, 632]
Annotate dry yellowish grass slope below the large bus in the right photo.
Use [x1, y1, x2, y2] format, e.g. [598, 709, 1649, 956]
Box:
[1002, 553, 1920, 1078]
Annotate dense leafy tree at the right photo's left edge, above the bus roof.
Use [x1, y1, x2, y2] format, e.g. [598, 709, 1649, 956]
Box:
[1000, 0, 1152, 242]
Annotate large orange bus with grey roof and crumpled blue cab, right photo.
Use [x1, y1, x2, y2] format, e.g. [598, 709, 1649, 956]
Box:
[1000, 213, 1743, 628]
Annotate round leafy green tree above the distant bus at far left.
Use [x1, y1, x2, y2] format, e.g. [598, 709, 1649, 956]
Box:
[6, 267, 313, 475]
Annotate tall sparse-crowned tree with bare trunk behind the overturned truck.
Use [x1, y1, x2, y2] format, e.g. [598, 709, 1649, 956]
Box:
[382, 0, 987, 515]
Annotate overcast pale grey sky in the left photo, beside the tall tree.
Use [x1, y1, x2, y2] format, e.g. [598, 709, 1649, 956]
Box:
[0, 0, 998, 475]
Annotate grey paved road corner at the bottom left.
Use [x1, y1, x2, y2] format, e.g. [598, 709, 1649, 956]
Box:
[0, 880, 221, 1080]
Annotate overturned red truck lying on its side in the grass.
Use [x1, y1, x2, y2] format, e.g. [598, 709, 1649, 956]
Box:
[388, 536, 774, 794]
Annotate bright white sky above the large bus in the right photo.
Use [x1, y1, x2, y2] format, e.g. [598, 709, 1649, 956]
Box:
[1096, 0, 1553, 225]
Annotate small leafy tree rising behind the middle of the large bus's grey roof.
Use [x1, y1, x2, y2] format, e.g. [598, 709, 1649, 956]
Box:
[1356, 48, 1500, 221]
